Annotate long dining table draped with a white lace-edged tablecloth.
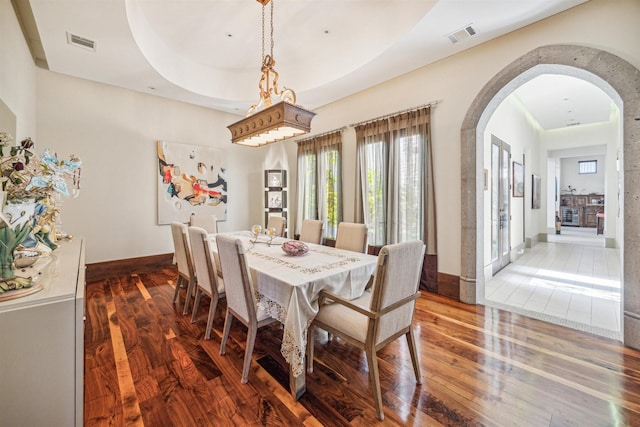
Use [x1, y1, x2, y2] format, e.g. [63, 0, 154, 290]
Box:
[208, 231, 378, 400]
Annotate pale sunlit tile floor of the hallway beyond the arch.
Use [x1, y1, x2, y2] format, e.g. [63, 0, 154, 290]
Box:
[485, 227, 622, 340]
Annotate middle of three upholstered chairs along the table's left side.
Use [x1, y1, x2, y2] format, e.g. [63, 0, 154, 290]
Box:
[189, 226, 225, 340]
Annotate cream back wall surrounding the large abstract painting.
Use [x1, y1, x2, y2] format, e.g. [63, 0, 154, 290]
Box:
[36, 70, 267, 263]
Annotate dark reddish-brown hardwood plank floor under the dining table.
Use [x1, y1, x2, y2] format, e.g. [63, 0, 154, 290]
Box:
[84, 269, 640, 426]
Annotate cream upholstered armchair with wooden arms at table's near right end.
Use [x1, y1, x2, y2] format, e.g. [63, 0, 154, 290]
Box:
[307, 240, 424, 420]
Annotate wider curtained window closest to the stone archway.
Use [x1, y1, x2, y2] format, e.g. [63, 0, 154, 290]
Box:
[356, 105, 435, 246]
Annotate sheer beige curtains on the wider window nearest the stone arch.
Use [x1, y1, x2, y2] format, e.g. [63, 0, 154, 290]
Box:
[356, 107, 437, 255]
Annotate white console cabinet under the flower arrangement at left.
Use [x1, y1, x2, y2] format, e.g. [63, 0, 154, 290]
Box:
[0, 239, 85, 427]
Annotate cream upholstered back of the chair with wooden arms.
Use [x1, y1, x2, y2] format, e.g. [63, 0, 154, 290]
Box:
[370, 240, 425, 344]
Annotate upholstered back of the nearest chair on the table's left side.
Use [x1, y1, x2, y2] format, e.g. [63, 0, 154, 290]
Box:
[216, 234, 256, 323]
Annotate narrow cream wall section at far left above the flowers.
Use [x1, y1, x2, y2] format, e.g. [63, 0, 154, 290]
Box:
[0, 0, 36, 142]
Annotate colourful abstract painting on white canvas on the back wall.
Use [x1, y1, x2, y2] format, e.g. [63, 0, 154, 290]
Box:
[157, 141, 227, 224]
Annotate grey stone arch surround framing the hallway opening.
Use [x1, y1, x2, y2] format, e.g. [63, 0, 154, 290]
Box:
[460, 45, 640, 348]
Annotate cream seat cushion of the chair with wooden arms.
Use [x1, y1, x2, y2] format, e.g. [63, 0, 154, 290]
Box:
[316, 291, 371, 343]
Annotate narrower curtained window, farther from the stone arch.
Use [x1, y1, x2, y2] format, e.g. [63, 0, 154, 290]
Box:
[296, 132, 342, 239]
